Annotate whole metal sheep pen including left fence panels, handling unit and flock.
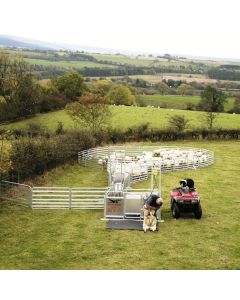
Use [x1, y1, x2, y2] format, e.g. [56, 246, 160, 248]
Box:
[0, 146, 214, 220]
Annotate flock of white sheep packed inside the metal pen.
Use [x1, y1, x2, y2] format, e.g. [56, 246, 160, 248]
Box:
[98, 148, 212, 180]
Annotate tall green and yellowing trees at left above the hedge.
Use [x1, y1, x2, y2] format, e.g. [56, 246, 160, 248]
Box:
[0, 54, 136, 122]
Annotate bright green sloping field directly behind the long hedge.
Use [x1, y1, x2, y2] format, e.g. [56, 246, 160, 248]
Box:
[0, 106, 240, 130]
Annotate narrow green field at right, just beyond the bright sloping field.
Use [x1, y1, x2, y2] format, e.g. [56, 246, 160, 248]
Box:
[141, 95, 234, 112]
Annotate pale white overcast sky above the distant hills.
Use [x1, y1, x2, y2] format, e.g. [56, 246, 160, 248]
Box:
[0, 0, 240, 59]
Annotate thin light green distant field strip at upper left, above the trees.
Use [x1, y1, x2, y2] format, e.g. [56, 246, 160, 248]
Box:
[25, 58, 114, 69]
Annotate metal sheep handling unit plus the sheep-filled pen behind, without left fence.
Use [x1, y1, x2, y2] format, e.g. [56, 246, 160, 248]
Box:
[78, 146, 214, 231]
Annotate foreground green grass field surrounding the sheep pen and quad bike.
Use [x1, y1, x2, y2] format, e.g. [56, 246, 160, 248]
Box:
[0, 142, 240, 270]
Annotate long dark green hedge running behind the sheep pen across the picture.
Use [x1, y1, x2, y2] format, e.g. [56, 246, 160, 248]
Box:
[3, 124, 240, 181]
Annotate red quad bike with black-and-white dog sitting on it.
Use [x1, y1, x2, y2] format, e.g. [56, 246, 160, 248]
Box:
[171, 179, 202, 219]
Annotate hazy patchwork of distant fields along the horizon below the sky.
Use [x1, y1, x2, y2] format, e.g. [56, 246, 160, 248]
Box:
[5, 49, 240, 92]
